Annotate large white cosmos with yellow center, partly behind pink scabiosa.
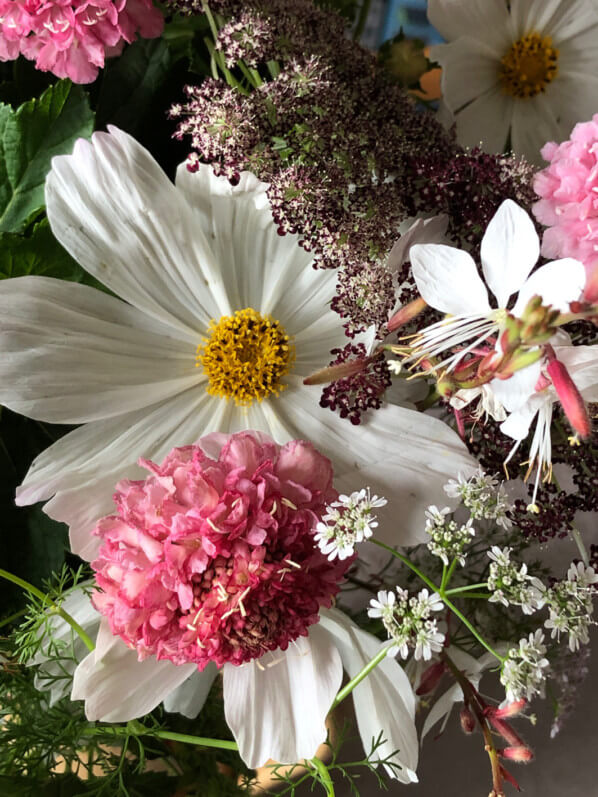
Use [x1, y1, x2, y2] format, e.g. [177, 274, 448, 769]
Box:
[0, 128, 474, 559]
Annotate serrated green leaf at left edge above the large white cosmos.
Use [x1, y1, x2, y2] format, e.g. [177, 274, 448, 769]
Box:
[0, 80, 93, 232]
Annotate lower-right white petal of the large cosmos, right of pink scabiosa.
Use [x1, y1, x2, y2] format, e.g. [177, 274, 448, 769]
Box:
[270, 380, 477, 545]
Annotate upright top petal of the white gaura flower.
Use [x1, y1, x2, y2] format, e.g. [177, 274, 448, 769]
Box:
[480, 199, 540, 307]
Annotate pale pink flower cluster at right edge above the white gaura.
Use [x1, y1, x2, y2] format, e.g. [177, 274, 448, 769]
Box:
[533, 114, 598, 300]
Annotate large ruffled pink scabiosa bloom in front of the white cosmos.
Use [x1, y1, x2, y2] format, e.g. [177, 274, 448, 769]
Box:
[92, 432, 352, 670]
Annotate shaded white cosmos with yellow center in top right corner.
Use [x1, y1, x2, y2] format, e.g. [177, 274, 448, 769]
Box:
[428, 0, 598, 164]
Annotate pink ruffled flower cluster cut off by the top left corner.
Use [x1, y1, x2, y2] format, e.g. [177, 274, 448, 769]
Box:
[0, 0, 164, 83]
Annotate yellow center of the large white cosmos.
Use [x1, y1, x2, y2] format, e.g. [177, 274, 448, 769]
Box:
[195, 307, 295, 406]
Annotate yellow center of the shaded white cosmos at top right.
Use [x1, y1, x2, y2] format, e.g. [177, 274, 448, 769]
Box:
[498, 33, 559, 99]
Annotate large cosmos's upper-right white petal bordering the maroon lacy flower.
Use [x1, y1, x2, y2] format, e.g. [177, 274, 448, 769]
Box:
[176, 164, 316, 318]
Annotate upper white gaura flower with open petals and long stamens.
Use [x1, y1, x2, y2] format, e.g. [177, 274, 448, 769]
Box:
[411, 199, 586, 376]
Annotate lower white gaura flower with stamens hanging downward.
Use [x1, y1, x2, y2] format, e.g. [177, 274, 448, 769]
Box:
[502, 345, 598, 508]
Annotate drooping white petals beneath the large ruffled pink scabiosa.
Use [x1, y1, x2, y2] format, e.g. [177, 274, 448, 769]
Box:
[52, 591, 418, 783]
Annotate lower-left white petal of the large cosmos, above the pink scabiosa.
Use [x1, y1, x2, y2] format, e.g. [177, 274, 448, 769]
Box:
[17, 388, 237, 560]
